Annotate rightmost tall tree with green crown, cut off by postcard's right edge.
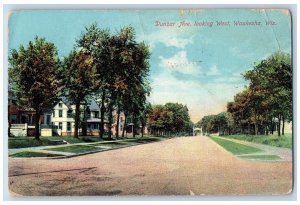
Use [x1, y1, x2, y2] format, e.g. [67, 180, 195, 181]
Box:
[244, 51, 292, 136]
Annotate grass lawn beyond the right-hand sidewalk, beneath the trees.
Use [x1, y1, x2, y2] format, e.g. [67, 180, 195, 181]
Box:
[222, 134, 293, 149]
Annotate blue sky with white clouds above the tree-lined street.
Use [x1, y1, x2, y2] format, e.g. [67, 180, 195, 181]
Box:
[9, 9, 291, 122]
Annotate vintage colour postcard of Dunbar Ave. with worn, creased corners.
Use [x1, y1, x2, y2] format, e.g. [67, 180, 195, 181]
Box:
[7, 8, 293, 196]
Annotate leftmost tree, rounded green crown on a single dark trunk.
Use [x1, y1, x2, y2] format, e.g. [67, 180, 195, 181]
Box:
[9, 37, 59, 140]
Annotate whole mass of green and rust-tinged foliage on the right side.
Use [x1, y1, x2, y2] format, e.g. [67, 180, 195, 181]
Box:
[227, 52, 293, 135]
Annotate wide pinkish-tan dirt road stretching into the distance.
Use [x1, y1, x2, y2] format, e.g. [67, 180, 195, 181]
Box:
[9, 137, 292, 196]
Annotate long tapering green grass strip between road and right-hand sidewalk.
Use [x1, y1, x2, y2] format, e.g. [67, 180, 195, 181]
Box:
[211, 137, 263, 155]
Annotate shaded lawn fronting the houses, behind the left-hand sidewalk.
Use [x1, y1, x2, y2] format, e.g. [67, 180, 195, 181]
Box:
[8, 136, 103, 149]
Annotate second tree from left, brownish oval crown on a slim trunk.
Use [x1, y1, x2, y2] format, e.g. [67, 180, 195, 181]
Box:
[62, 49, 97, 137]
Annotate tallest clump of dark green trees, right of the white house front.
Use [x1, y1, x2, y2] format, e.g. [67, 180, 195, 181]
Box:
[77, 24, 151, 138]
